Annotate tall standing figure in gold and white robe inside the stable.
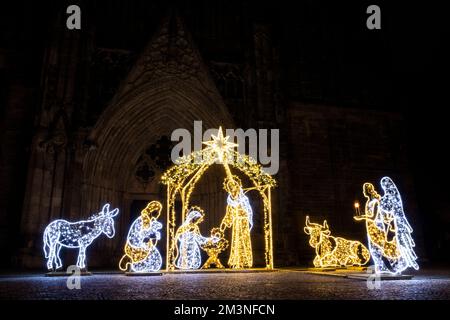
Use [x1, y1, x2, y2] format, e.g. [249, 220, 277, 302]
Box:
[220, 176, 253, 269]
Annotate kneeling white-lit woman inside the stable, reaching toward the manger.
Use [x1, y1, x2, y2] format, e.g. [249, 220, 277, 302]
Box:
[175, 207, 213, 270]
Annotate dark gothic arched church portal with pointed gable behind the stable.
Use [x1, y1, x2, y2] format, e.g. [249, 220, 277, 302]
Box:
[80, 17, 234, 265]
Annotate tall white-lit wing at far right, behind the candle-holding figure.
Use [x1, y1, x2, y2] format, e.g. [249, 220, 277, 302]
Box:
[380, 177, 419, 270]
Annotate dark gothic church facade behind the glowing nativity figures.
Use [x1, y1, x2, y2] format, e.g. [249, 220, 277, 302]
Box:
[0, 1, 422, 268]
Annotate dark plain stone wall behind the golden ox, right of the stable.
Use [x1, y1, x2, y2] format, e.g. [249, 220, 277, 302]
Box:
[278, 103, 423, 264]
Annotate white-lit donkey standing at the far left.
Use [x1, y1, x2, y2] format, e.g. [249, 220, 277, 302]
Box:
[44, 203, 119, 270]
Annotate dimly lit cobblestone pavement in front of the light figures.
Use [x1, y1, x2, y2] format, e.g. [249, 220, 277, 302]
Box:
[0, 270, 450, 300]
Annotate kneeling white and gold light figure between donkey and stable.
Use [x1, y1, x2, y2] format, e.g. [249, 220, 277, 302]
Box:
[119, 201, 162, 273]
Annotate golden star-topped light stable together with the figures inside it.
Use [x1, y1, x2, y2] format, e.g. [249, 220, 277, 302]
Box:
[162, 128, 275, 271]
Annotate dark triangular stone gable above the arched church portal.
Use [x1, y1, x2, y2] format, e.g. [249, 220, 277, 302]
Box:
[107, 14, 232, 123]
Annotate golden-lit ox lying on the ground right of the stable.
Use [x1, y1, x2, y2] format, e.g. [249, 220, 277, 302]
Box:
[304, 216, 370, 268]
